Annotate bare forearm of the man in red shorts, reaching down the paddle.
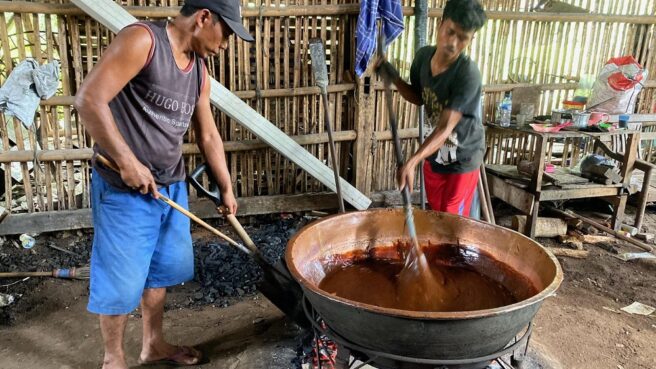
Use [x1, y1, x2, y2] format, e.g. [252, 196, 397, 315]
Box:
[397, 109, 462, 189]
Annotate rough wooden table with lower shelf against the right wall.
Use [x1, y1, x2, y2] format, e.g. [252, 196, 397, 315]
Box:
[486, 124, 640, 237]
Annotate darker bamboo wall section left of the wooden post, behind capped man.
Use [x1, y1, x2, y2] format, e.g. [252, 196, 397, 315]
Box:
[0, 0, 357, 212]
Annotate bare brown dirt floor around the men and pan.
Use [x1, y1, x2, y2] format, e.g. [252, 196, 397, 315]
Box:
[0, 209, 656, 369]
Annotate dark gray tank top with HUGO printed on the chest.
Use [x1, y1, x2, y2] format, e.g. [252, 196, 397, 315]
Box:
[92, 21, 205, 190]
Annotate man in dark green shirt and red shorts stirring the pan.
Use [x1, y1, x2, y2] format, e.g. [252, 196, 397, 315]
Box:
[380, 0, 487, 216]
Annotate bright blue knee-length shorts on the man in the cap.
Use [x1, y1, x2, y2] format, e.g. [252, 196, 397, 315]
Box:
[87, 170, 194, 315]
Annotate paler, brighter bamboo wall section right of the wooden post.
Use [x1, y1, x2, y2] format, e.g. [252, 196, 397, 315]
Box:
[372, 0, 656, 191]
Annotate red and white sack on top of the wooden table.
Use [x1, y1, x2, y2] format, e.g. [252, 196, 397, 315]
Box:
[587, 55, 647, 114]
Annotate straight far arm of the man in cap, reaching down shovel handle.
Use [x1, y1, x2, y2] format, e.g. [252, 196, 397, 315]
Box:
[192, 67, 237, 214]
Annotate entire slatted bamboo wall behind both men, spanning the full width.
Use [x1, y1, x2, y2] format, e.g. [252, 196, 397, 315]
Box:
[0, 0, 656, 221]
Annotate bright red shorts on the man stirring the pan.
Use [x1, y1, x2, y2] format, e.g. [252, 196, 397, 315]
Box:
[424, 161, 479, 217]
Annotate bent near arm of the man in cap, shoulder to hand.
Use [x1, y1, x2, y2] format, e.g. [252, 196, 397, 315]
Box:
[75, 27, 158, 197]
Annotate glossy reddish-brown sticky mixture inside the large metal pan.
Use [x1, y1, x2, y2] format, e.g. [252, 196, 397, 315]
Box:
[319, 242, 538, 312]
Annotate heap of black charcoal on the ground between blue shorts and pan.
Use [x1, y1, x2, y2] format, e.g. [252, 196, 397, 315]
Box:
[192, 217, 308, 306]
